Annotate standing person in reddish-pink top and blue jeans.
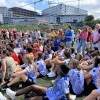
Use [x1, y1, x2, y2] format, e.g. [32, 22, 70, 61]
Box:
[77, 27, 88, 57]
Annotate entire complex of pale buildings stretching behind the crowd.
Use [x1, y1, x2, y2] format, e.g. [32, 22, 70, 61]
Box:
[0, 4, 88, 25]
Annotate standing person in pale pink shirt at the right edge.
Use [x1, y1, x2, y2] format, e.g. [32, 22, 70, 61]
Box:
[92, 24, 100, 50]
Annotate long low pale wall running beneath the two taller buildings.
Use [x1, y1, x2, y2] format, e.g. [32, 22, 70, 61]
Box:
[10, 15, 85, 25]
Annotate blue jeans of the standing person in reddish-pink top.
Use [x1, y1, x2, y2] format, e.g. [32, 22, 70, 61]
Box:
[77, 39, 87, 57]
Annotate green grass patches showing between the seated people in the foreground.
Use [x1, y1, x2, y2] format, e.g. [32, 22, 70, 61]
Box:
[0, 77, 84, 100]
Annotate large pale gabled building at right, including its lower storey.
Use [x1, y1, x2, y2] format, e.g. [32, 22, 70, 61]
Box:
[42, 4, 88, 24]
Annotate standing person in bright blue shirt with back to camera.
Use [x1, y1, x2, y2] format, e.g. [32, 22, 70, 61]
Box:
[65, 25, 73, 48]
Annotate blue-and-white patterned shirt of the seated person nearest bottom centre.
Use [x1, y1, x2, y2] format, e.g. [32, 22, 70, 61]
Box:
[46, 77, 69, 100]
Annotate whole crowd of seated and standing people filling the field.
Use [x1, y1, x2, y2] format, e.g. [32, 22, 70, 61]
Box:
[0, 24, 100, 100]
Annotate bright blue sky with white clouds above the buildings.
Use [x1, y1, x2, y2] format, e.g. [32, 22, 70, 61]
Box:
[0, 0, 100, 19]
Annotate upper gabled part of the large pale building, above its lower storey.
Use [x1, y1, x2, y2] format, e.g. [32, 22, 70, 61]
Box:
[42, 4, 87, 15]
